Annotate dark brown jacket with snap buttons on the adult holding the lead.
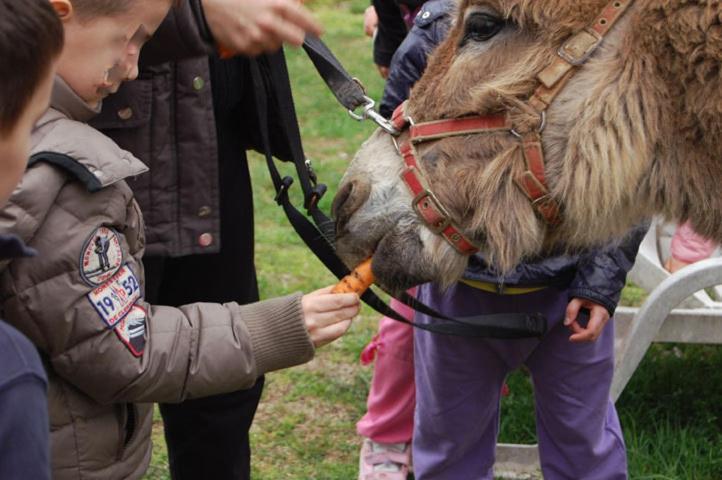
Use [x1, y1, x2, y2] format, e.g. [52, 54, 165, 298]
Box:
[91, 0, 220, 256]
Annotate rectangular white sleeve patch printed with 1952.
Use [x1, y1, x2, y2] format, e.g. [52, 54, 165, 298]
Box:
[87, 265, 140, 328]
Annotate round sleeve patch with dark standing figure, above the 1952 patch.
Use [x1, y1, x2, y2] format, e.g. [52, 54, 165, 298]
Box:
[80, 227, 123, 286]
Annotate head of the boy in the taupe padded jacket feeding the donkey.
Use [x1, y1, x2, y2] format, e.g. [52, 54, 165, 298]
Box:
[50, 0, 171, 106]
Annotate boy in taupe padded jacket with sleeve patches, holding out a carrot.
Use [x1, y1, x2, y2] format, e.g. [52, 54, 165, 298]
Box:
[0, 0, 359, 479]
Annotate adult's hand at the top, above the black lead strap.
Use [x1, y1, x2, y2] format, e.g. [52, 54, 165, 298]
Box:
[201, 0, 322, 56]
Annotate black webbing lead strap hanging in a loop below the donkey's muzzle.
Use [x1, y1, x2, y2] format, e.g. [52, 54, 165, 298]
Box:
[250, 48, 546, 338]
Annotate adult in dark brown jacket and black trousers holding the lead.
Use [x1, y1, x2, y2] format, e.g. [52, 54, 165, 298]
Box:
[91, 0, 320, 480]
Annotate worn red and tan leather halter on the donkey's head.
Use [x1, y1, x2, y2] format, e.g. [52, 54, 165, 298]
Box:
[391, 0, 634, 255]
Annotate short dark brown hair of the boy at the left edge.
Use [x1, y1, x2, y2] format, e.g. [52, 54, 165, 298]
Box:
[0, 0, 64, 134]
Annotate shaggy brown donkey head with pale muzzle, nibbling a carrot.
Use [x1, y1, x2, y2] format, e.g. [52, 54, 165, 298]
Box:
[334, 0, 704, 290]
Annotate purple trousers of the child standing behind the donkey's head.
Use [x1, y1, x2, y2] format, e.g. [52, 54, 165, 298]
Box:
[413, 284, 627, 480]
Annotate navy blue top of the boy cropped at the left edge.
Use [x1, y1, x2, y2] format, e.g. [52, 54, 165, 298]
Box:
[0, 235, 50, 480]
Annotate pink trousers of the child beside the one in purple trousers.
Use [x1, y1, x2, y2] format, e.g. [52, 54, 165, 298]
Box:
[356, 289, 416, 443]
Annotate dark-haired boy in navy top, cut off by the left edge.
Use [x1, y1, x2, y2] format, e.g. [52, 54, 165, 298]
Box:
[0, 0, 63, 480]
